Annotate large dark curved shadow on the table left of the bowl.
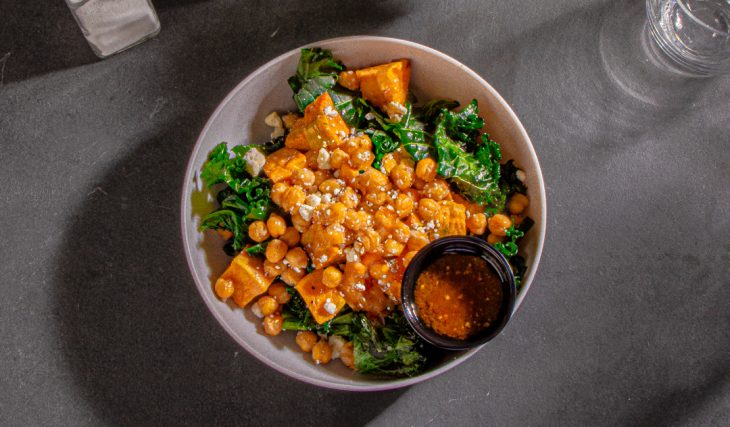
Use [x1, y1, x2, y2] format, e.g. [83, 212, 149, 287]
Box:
[52, 1, 412, 425]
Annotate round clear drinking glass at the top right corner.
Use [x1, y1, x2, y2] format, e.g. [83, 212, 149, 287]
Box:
[646, 0, 730, 76]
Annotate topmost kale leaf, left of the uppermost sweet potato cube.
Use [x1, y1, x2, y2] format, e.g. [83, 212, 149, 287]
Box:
[288, 47, 343, 112]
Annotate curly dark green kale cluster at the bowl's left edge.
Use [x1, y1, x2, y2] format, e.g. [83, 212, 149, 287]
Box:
[200, 142, 271, 255]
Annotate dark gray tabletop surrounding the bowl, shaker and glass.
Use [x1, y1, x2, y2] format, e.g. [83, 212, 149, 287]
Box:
[0, 0, 730, 426]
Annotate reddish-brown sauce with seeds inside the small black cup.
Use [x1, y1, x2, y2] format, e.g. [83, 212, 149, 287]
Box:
[414, 254, 502, 339]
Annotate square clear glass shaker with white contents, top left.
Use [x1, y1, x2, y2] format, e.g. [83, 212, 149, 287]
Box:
[66, 0, 160, 58]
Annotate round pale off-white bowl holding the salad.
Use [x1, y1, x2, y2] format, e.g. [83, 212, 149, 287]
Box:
[181, 36, 545, 391]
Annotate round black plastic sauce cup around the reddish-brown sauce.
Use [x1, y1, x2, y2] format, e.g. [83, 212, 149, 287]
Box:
[401, 236, 517, 350]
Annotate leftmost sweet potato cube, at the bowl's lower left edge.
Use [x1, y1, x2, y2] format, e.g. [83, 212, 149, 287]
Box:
[216, 251, 274, 307]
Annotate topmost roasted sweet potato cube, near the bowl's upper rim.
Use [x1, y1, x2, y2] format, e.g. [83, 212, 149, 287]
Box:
[355, 59, 411, 117]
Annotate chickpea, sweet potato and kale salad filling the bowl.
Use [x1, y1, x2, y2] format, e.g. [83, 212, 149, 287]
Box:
[200, 48, 532, 376]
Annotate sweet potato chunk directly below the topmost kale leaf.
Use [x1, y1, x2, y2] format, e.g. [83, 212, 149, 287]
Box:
[285, 92, 350, 150]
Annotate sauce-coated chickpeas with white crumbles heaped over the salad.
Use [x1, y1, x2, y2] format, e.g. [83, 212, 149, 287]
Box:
[239, 98, 528, 369]
